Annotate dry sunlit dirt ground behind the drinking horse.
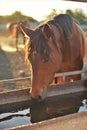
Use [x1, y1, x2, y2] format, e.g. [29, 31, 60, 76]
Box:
[0, 31, 87, 92]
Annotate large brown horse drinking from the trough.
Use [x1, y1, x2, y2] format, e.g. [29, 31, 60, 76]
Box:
[20, 14, 86, 99]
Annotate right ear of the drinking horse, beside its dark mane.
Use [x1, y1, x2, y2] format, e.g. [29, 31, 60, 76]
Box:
[42, 24, 51, 40]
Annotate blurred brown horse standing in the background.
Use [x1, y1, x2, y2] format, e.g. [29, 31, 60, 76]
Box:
[7, 20, 29, 50]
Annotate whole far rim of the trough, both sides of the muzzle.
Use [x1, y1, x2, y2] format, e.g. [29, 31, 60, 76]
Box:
[0, 80, 87, 105]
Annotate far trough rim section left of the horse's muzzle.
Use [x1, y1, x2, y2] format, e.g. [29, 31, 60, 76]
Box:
[0, 89, 31, 105]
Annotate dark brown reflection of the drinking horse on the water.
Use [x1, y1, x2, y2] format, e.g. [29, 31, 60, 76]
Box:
[30, 98, 79, 123]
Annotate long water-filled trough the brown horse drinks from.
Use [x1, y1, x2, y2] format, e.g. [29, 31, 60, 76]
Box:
[0, 70, 87, 130]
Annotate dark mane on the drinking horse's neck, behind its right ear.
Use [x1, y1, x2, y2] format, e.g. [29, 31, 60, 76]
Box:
[48, 14, 74, 55]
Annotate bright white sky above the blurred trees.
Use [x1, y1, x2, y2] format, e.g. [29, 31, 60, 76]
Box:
[0, 0, 87, 21]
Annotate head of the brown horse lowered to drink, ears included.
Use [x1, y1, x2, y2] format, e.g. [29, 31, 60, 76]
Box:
[20, 24, 61, 99]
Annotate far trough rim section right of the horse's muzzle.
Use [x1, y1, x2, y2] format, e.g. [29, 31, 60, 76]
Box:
[47, 80, 87, 97]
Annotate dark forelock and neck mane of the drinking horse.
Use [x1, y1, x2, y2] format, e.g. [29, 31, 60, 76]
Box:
[30, 14, 74, 60]
